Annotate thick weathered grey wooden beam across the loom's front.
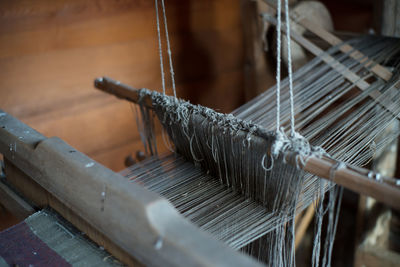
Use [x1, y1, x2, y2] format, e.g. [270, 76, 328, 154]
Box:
[0, 110, 260, 266]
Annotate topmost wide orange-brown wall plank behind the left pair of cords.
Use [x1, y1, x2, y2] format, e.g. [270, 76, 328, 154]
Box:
[0, 0, 240, 58]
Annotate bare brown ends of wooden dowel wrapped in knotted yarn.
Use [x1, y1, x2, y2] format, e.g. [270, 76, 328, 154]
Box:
[95, 77, 400, 211]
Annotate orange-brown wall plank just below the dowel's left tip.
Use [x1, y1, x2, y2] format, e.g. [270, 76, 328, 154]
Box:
[28, 102, 140, 168]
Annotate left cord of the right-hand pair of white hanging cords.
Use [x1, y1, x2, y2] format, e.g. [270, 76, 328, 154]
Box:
[276, 0, 282, 132]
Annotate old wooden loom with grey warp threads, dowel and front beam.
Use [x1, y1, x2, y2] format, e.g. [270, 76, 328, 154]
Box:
[0, 1, 400, 266]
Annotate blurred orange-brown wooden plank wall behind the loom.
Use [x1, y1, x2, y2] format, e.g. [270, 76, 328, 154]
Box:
[0, 0, 243, 170]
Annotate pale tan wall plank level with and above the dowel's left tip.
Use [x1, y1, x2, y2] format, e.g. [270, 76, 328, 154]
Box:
[0, 32, 242, 116]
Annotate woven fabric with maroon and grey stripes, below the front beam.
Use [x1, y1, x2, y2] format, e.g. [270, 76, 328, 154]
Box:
[0, 210, 122, 267]
